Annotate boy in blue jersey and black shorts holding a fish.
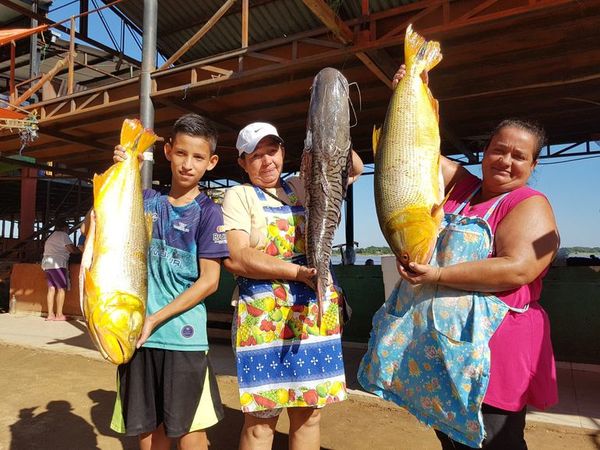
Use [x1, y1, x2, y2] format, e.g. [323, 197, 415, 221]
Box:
[111, 114, 228, 450]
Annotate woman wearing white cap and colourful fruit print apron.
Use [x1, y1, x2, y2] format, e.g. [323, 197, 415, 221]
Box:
[223, 122, 363, 450]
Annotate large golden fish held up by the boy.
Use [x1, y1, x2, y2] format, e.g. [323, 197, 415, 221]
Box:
[80, 119, 156, 364]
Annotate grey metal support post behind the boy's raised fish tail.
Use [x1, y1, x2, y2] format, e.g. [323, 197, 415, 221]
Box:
[140, 0, 158, 189]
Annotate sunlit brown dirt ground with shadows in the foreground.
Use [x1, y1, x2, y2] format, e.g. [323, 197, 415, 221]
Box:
[0, 344, 600, 450]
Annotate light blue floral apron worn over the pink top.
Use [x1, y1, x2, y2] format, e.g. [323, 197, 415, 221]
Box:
[358, 190, 527, 447]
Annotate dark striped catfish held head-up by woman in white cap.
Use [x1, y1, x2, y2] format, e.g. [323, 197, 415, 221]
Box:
[301, 67, 351, 312]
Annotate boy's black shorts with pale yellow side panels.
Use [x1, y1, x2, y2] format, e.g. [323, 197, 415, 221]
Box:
[110, 347, 223, 438]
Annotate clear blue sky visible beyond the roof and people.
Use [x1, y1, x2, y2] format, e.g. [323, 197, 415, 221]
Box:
[50, 0, 600, 247]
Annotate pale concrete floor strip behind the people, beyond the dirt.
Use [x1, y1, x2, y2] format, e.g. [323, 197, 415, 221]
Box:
[0, 314, 600, 431]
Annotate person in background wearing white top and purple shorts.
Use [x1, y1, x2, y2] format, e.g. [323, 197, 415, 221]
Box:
[42, 219, 79, 321]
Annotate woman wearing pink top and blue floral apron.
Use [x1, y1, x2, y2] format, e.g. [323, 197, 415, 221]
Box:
[359, 67, 559, 450]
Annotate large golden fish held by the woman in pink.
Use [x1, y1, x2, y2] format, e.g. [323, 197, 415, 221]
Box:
[373, 25, 444, 268]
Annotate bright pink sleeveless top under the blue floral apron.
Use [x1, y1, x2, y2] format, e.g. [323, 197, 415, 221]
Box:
[444, 174, 558, 411]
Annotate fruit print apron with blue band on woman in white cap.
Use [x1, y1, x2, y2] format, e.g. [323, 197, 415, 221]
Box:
[236, 179, 347, 412]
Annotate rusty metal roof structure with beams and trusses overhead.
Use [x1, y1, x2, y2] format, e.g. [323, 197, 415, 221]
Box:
[0, 0, 600, 218]
